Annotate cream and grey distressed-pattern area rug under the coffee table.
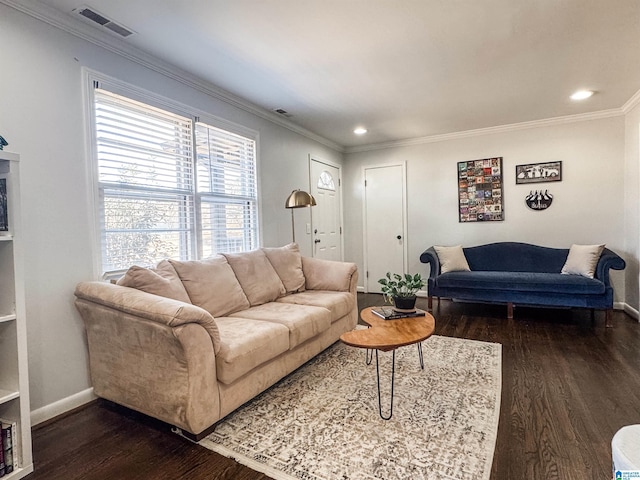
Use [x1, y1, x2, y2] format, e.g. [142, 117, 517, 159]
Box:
[200, 336, 502, 480]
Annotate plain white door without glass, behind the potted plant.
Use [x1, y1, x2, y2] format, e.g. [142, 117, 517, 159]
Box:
[364, 165, 407, 293]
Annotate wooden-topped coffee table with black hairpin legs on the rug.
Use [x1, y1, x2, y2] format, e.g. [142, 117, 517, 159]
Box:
[340, 307, 436, 420]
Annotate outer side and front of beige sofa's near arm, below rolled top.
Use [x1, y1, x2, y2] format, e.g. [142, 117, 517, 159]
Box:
[75, 297, 220, 435]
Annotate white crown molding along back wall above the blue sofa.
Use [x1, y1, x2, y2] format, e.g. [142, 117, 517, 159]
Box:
[344, 108, 624, 154]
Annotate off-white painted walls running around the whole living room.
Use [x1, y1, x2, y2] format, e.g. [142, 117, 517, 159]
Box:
[0, 0, 640, 420]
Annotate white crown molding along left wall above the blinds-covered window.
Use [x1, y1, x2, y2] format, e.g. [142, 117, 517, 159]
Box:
[0, 0, 344, 152]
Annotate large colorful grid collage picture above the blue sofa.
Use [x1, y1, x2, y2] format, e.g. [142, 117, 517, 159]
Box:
[458, 157, 504, 223]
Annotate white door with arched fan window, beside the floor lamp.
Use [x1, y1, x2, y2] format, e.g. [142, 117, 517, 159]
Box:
[309, 159, 342, 261]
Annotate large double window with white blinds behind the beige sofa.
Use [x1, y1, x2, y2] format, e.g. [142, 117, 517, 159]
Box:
[94, 83, 258, 272]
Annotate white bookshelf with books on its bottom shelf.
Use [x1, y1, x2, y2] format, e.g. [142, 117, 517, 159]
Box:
[0, 151, 33, 480]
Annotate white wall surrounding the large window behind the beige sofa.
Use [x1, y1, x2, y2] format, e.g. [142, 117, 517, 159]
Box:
[0, 4, 342, 413]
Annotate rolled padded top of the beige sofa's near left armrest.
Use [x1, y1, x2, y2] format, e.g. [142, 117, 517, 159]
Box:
[75, 282, 220, 354]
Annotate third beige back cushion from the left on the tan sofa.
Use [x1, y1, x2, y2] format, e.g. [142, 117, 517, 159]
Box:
[223, 250, 286, 306]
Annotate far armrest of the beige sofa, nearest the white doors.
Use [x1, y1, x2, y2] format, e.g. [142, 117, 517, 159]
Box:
[302, 257, 358, 294]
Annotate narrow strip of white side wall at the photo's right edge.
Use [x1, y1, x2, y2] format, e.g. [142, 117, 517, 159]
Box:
[624, 105, 640, 314]
